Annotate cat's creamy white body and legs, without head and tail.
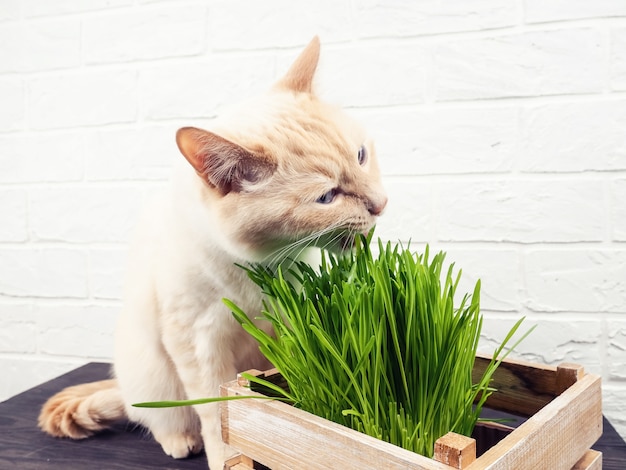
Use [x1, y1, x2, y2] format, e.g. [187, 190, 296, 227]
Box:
[115, 164, 276, 468]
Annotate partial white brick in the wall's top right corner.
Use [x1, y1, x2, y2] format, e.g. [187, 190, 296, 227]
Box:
[524, 0, 626, 23]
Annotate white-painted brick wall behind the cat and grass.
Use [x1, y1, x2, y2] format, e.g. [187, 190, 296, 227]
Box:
[0, 0, 626, 436]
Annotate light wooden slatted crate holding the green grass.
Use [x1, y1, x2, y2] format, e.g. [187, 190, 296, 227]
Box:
[220, 356, 602, 470]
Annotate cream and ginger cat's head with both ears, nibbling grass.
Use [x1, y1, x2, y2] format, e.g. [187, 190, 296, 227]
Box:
[176, 37, 387, 261]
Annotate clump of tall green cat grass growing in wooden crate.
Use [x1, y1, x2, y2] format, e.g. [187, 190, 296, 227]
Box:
[225, 237, 529, 456]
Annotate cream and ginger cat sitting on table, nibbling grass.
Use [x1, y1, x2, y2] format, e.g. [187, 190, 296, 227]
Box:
[39, 37, 387, 470]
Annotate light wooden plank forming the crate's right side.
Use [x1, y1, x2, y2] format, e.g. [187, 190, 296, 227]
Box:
[468, 374, 602, 470]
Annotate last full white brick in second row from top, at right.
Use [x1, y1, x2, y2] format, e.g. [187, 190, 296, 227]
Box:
[432, 28, 606, 101]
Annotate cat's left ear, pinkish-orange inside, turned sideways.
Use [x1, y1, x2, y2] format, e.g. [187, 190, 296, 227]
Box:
[176, 127, 276, 195]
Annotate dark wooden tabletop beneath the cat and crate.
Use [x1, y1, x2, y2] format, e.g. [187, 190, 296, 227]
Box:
[0, 363, 626, 470]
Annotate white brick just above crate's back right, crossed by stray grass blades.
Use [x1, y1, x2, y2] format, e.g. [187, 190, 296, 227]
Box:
[479, 314, 604, 374]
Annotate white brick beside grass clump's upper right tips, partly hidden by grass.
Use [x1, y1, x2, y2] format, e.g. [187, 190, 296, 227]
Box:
[438, 245, 522, 312]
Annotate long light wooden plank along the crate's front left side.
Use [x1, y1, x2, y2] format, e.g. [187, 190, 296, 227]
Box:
[220, 381, 453, 470]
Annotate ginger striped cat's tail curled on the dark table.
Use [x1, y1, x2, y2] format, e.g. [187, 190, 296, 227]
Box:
[39, 380, 126, 439]
